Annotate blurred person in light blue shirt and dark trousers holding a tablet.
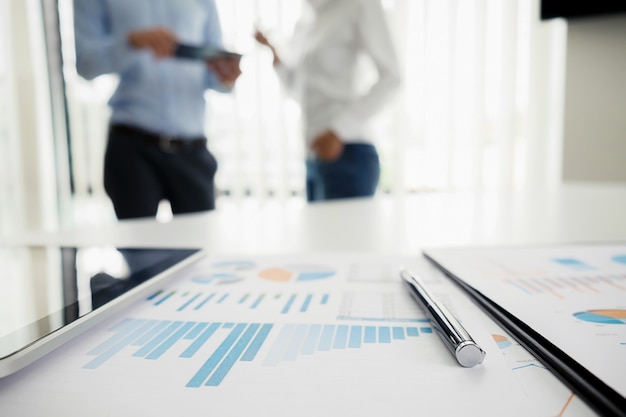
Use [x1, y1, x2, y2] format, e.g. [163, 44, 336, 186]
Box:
[74, 0, 241, 219]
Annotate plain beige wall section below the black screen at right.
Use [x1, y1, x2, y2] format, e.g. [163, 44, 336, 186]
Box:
[563, 15, 626, 181]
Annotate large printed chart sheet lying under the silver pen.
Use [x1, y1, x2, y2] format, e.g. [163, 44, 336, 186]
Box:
[0, 254, 588, 417]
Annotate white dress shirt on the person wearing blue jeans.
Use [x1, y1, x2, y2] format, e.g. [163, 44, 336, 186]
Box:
[276, 0, 400, 144]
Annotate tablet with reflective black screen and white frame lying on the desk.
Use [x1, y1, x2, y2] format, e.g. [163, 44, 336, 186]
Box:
[0, 246, 201, 378]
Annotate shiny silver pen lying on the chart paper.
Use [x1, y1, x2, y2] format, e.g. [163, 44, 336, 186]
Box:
[400, 269, 486, 368]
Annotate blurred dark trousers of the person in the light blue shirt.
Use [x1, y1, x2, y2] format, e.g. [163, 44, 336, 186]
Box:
[104, 126, 217, 219]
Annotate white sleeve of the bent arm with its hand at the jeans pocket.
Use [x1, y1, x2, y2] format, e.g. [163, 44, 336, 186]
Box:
[330, 0, 400, 138]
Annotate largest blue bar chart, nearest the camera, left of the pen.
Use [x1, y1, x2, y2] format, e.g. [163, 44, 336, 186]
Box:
[83, 319, 432, 388]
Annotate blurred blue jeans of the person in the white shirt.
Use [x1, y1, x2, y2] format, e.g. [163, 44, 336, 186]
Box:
[306, 143, 380, 201]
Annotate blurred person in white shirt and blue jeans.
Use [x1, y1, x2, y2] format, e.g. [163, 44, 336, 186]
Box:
[255, 0, 400, 201]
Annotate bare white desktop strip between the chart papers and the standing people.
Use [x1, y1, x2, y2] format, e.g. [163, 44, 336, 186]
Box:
[0, 184, 626, 250]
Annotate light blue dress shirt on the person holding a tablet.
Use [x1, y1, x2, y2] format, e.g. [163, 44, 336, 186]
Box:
[74, 0, 227, 138]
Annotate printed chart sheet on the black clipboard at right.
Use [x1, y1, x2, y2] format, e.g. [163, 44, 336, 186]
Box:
[425, 244, 626, 413]
